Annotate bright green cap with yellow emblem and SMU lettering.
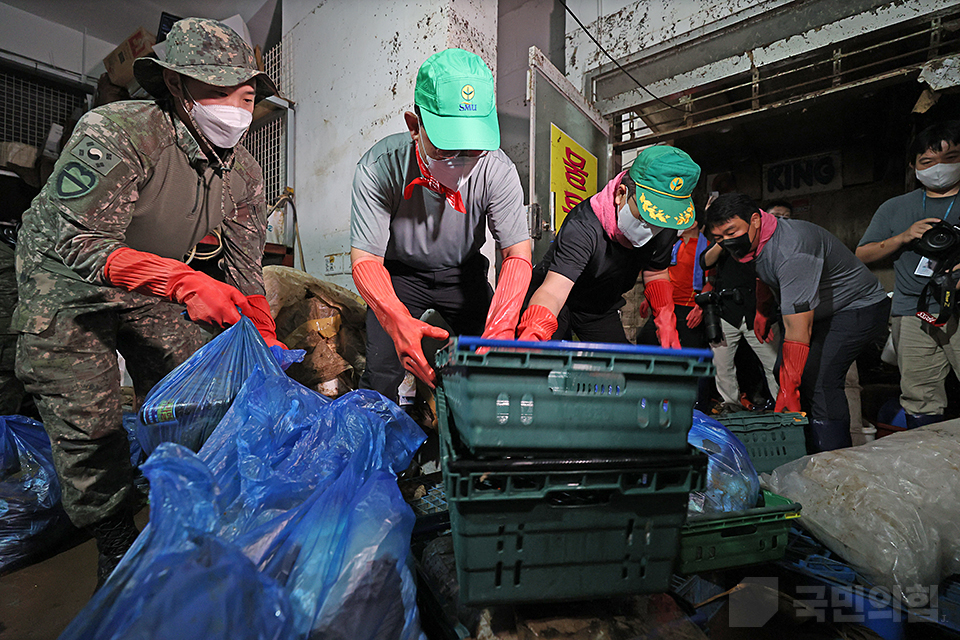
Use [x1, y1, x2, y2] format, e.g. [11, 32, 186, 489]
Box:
[413, 49, 500, 151]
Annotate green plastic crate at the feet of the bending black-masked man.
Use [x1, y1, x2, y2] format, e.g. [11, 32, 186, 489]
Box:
[717, 411, 807, 473]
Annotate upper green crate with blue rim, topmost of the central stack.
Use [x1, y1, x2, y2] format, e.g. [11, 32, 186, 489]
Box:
[437, 338, 714, 453]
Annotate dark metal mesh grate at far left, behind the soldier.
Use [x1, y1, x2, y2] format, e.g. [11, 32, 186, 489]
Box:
[0, 69, 86, 151]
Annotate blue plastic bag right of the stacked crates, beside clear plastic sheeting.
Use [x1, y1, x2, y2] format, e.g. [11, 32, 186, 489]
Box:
[687, 411, 760, 513]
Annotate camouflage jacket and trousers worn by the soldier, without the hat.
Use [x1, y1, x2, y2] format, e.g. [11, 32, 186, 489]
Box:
[13, 101, 266, 527]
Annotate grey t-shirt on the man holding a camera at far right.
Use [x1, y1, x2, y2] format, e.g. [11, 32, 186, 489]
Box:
[859, 189, 960, 316]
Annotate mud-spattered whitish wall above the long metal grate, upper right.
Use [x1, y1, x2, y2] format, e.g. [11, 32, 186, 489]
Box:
[566, 0, 957, 107]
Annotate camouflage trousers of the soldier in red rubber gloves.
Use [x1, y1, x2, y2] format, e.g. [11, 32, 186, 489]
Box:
[17, 292, 203, 527]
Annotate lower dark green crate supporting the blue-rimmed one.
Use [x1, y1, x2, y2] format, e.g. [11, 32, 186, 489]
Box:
[441, 416, 706, 606]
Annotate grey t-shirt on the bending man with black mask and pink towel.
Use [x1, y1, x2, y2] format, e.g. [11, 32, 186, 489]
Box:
[757, 218, 887, 320]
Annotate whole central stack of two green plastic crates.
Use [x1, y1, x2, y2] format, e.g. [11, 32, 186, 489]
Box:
[437, 337, 713, 604]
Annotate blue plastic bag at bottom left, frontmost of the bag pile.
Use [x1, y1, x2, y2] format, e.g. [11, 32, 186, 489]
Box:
[60, 443, 293, 640]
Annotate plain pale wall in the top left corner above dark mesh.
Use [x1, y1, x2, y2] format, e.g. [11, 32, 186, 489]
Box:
[0, 3, 119, 84]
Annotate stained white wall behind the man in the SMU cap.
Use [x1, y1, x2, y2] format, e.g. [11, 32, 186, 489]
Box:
[284, 0, 497, 290]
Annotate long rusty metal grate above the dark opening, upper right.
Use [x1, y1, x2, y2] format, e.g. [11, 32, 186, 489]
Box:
[611, 13, 960, 152]
